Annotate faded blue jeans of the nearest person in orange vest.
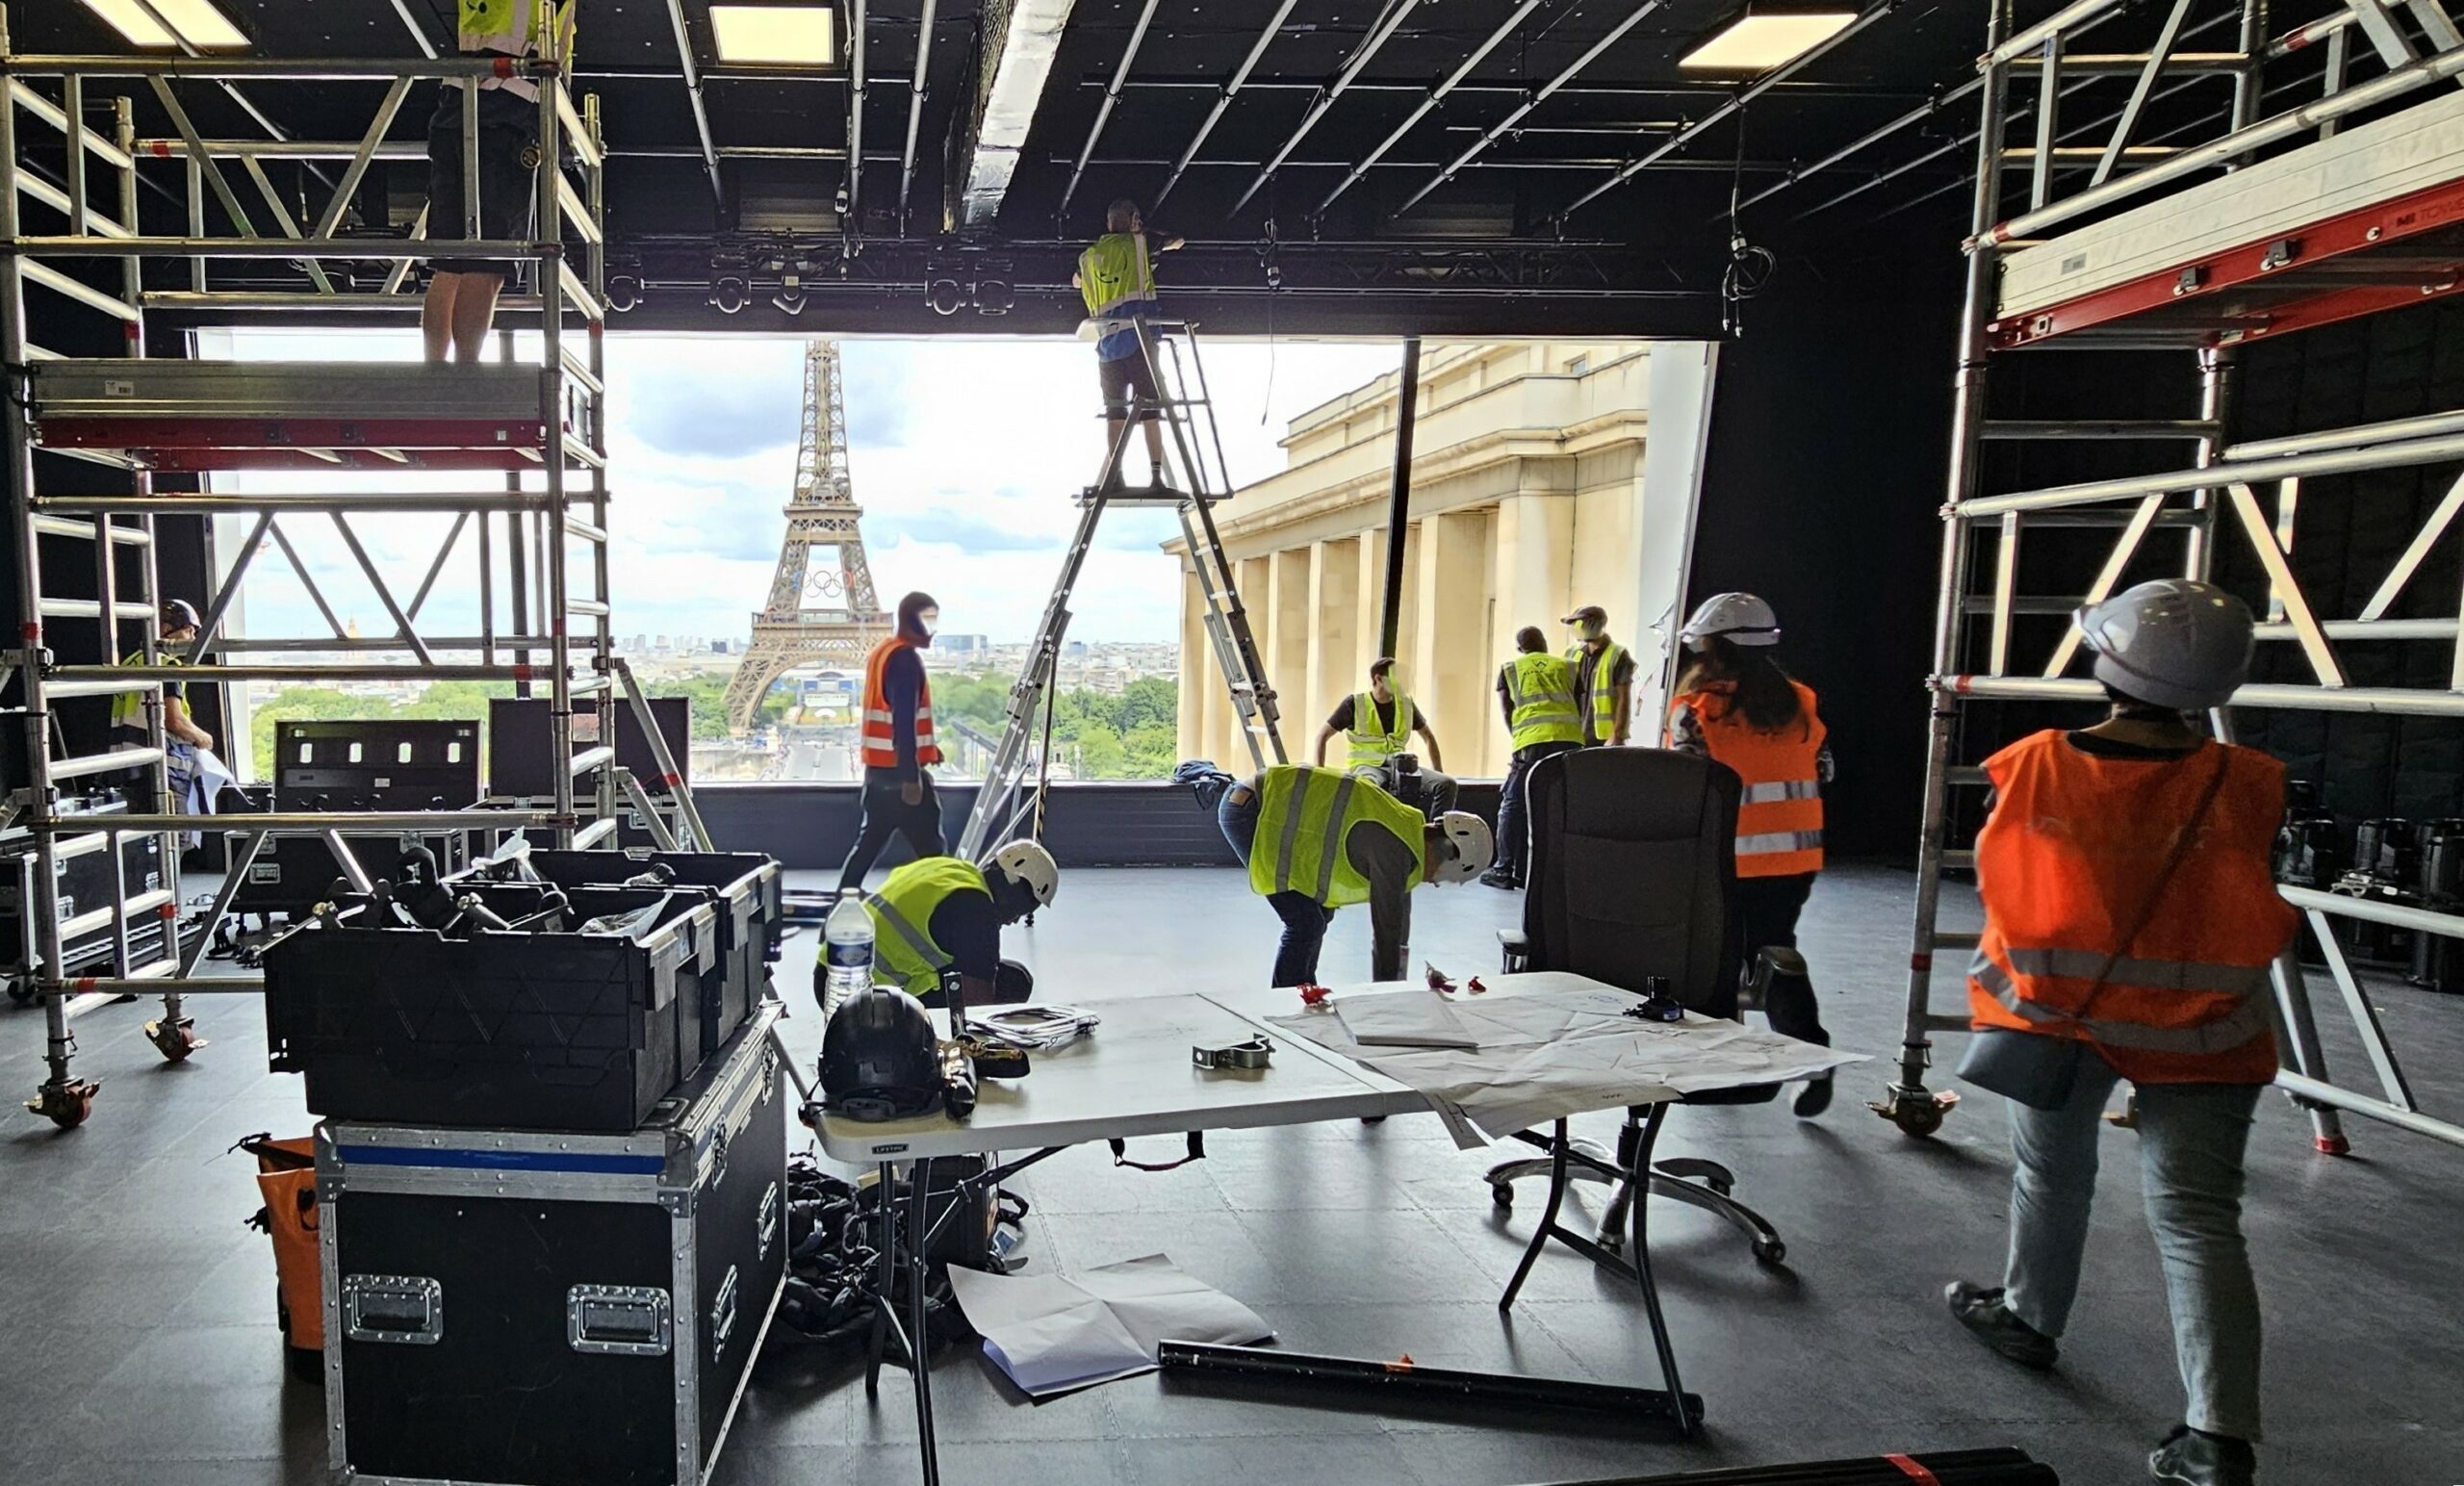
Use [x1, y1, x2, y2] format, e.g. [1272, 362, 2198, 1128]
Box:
[2003, 1055, 2260, 1442]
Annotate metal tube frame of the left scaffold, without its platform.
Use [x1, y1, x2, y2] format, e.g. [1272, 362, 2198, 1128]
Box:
[0, 8, 675, 1126]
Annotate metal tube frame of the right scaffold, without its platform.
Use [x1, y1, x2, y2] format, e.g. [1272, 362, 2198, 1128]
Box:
[1870, 0, 2464, 1156]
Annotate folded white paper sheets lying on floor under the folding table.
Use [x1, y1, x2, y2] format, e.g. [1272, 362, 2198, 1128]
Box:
[949, 1254, 1274, 1397]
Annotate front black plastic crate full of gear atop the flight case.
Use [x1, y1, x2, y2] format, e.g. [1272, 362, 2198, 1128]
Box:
[264, 884, 720, 1131]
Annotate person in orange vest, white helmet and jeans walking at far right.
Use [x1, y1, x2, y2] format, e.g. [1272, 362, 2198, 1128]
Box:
[1944, 579, 2297, 1486]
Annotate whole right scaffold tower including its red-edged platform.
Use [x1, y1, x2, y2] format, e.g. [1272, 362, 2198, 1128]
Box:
[1873, 0, 2464, 1153]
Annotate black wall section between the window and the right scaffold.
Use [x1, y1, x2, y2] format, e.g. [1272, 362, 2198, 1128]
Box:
[1688, 256, 1959, 858]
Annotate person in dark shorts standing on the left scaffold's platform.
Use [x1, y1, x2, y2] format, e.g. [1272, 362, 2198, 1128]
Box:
[419, 0, 574, 362]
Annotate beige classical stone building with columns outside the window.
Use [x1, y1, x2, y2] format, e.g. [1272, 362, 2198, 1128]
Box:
[1168, 343, 1707, 779]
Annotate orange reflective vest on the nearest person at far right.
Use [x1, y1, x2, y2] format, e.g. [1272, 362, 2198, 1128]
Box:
[1968, 731, 2298, 1085]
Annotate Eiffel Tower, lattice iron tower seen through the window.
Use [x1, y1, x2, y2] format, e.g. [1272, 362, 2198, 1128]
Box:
[727, 340, 889, 731]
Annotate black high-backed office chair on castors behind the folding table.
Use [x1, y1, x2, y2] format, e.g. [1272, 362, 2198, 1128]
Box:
[1488, 749, 1789, 1267]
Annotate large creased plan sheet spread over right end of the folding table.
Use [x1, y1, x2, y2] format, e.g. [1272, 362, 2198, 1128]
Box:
[1267, 976, 1862, 1148]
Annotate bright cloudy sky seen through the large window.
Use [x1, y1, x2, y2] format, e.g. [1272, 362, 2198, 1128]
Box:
[207, 330, 1399, 643]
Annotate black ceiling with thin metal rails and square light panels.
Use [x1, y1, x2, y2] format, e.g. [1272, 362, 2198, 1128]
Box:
[10, 0, 2385, 333]
